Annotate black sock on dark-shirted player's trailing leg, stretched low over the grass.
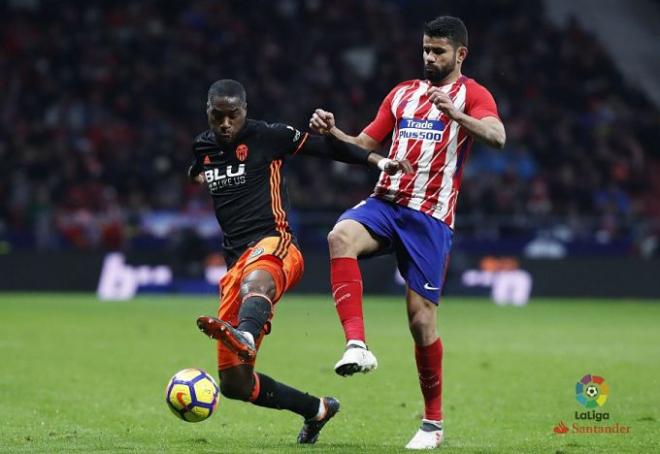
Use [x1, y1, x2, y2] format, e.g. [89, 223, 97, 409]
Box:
[252, 373, 319, 419]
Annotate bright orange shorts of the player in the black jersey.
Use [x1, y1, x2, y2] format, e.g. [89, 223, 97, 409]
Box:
[218, 236, 305, 370]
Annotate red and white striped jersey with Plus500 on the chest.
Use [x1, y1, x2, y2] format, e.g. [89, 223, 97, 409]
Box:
[362, 76, 499, 228]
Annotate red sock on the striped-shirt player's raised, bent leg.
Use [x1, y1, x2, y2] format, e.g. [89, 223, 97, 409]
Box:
[330, 257, 364, 342]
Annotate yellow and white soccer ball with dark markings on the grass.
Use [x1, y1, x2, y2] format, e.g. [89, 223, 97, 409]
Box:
[165, 369, 219, 422]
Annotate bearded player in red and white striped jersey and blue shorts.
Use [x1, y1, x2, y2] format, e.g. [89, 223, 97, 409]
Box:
[310, 16, 506, 449]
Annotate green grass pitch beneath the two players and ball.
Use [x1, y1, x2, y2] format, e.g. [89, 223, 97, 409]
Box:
[0, 294, 660, 453]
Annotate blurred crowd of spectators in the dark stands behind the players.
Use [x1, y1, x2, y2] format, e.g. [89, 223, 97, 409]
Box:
[0, 0, 660, 254]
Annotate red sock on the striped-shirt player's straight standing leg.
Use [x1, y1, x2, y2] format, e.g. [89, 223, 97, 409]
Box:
[415, 338, 442, 421]
